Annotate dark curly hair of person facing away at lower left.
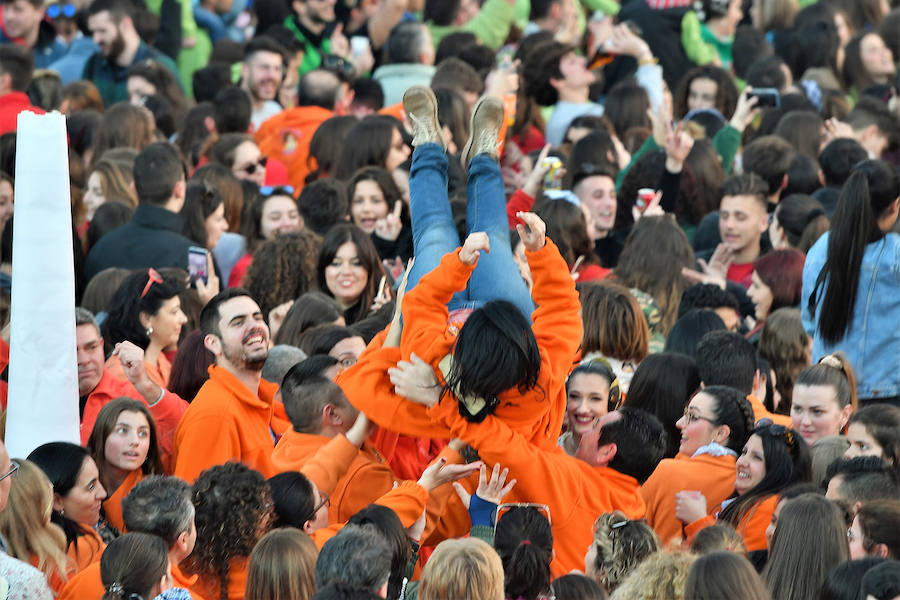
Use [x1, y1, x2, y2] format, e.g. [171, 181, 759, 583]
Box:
[182, 462, 273, 600]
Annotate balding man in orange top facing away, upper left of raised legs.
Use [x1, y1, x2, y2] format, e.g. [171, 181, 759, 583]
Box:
[253, 66, 341, 190]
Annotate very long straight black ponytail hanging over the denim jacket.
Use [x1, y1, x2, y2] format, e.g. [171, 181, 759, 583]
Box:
[807, 160, 900, 344]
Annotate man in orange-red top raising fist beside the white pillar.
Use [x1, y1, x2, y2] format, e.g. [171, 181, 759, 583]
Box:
[75, 307, 187, 458]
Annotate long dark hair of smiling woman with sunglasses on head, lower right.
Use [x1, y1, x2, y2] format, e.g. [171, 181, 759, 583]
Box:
[719, 425, 810, 530]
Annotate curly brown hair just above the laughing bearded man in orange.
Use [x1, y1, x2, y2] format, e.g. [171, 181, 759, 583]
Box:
[244, 231, 321, 321]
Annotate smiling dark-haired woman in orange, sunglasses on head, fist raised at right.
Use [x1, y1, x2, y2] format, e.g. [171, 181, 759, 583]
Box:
[675, 419, 810, 552]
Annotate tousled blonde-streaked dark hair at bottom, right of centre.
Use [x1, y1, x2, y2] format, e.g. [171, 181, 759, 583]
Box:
[592, 511, 660, 591]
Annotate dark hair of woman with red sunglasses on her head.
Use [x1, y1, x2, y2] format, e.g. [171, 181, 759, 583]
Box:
[101, 269, 179, 349]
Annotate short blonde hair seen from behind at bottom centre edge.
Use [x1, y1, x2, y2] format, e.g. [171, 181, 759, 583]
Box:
[419, 538, 503, 600]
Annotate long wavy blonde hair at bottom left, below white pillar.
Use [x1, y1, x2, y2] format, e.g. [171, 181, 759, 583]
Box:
[0, 458, 69, 581]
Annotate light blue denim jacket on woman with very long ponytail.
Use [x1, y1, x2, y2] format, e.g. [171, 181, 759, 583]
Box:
[800, 233, 900, 398]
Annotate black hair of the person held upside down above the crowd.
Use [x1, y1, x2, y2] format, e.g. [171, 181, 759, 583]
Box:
[444, 300, 541, 418]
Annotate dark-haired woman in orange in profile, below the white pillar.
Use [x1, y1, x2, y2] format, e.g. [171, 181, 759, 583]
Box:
[28, 442, 106, 576]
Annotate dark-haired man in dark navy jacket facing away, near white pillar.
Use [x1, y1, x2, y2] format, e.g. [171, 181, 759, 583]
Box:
[84, 142, 195, 280]
